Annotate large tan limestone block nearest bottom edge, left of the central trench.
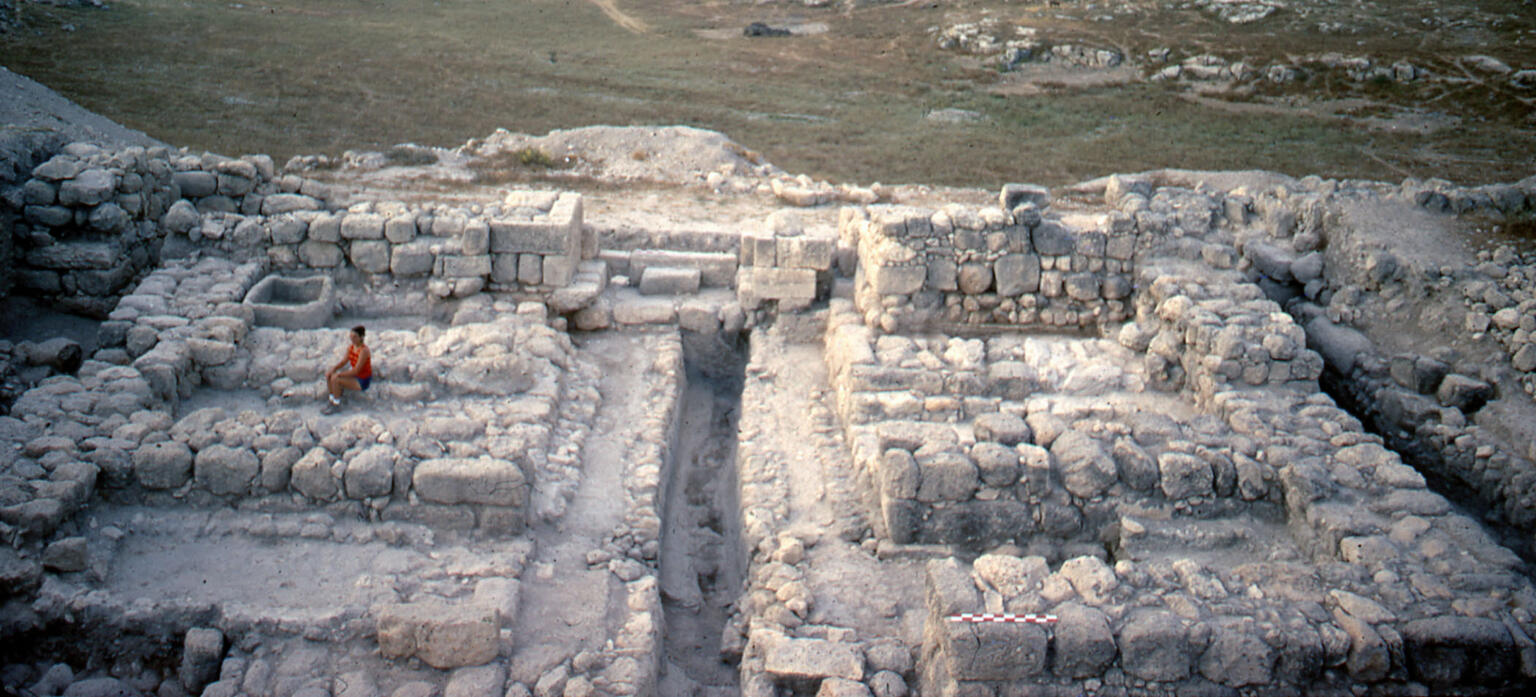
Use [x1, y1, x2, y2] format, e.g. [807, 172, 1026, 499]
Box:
[376, 603, 501, 669]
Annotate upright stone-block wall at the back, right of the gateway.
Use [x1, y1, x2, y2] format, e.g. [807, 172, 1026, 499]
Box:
[839, 192, 1137, 332]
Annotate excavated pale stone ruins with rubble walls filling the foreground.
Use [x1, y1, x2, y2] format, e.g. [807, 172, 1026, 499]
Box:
[0, 133, 1536, 697]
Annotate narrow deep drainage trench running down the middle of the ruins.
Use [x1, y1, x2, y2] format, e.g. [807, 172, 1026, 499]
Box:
[659, 333, 746, 697]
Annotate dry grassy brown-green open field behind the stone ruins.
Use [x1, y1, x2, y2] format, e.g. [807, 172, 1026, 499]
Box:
[0, 0, 1536, 187]
